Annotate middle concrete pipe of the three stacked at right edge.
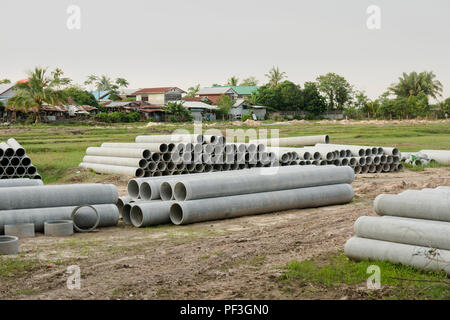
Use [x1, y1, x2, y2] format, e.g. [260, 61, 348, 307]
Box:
[354, 216, 450, 250]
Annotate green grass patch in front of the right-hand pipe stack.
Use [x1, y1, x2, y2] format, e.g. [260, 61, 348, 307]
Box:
[281, 253, 450, 299]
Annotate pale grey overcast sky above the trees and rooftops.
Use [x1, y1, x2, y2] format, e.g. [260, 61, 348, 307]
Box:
[0, 0, 450, 98]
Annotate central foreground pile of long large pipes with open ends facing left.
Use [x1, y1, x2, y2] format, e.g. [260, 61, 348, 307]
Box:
[118, 166, 355, 227]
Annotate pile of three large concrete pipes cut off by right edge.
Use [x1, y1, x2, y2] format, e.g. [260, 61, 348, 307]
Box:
[344, 186, 450, 274]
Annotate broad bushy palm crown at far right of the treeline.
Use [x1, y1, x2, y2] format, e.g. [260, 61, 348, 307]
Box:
[389, 71, 443, 99]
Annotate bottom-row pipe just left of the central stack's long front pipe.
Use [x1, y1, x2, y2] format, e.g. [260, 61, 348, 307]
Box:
[130, 201, 174, 228]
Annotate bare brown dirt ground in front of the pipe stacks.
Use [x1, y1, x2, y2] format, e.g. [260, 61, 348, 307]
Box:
[0, 168, 450, 299]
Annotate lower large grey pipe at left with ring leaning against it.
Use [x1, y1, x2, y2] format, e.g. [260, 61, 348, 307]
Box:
[0, 204, 119, 234]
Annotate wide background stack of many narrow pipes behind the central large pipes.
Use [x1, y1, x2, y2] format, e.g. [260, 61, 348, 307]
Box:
[79, 135, 310, 177]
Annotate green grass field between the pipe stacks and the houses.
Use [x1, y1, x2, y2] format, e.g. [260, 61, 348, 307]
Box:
[0, 122, 450, 183]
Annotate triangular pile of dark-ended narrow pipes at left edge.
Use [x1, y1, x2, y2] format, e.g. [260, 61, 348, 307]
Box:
[0, 138, 41, 179]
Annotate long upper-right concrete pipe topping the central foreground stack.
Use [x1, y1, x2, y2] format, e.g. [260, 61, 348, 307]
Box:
[173, 166, 355, 201]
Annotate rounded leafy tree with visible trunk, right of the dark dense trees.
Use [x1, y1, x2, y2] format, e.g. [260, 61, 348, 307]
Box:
[317, 73, 352, 110]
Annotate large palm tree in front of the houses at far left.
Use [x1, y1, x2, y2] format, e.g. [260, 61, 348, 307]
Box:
[7, 67, 67, 123]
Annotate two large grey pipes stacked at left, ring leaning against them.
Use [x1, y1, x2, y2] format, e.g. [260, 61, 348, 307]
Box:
[0, 179, 119, 234]
